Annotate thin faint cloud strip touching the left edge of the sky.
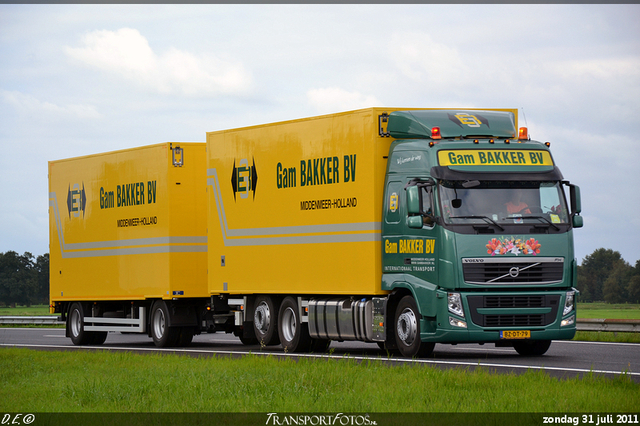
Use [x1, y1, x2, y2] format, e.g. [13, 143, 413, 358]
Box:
[0, 90, 102, 119]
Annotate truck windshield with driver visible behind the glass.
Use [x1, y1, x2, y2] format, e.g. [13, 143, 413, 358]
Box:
[439, 181, 569, 229]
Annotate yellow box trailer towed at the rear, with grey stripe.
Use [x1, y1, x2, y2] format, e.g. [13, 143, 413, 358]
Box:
[49, 143, 208, 343]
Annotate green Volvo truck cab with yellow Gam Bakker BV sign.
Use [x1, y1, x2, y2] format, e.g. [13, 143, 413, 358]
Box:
[380, 110, 582, 356]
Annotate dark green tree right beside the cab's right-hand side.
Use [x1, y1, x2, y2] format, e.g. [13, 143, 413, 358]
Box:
[578, 248, 623, 302]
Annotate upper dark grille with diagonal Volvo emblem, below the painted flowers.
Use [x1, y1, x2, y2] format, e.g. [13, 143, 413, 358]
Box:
[462, 258, 564, 284]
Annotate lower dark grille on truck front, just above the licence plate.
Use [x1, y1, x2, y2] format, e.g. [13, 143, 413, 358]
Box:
[467, 294, 560, 327]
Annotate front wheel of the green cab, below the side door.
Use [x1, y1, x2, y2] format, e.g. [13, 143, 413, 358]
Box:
[394, 296, 435, 358]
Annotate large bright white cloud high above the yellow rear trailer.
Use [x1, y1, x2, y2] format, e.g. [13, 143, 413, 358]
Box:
[65, 28, 251, 96]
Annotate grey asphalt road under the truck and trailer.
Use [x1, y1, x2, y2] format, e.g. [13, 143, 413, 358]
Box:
[0, 328, 640, 383]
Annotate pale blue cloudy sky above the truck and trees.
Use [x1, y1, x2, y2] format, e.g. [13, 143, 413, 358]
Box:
[0, 4, 640, 265]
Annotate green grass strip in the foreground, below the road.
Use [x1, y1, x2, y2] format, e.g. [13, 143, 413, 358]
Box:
[0, 348, 640, 413]
